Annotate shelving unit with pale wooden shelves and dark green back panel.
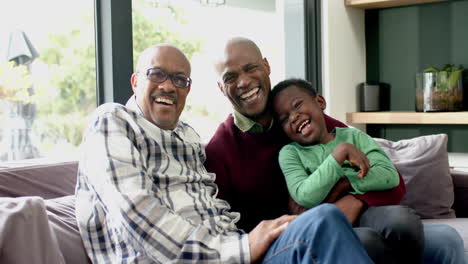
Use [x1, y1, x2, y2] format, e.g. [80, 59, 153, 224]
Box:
[341, 0, 468, 154]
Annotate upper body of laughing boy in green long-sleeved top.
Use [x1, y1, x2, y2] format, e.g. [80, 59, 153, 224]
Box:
[271, 79, 399, 212]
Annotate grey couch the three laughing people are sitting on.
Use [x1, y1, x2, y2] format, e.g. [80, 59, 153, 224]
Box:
[0, 134, 468, 263]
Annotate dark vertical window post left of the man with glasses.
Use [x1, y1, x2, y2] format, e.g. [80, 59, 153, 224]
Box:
[94, 0, 133, 105]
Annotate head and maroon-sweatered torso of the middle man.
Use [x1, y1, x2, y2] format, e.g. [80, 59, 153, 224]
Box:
[205, 37, 352, 231]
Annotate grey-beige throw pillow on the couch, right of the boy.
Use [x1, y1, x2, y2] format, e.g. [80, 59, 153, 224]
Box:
[375, 134, 455, 219]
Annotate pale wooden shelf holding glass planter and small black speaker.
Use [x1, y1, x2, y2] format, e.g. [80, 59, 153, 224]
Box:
[346, 111, 468, 125]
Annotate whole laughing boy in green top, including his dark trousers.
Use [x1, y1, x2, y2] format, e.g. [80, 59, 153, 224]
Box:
[269, 79, 424, 263]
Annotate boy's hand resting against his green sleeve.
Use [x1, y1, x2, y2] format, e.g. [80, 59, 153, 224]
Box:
[332, 142, 370, 178]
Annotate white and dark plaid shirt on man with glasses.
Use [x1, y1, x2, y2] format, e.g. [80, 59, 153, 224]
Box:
[76, 98, 250, 263]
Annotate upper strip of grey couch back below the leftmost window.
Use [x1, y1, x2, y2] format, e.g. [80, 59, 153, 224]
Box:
[0, 161, 78, 199]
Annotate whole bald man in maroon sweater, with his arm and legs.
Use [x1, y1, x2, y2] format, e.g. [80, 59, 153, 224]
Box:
[205, 37, 464, 264]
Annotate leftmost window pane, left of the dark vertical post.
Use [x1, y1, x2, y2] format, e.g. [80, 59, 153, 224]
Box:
[0, 0, 96, 162]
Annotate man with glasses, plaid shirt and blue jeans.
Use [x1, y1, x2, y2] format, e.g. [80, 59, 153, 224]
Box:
[76, 44, 371, 263]
